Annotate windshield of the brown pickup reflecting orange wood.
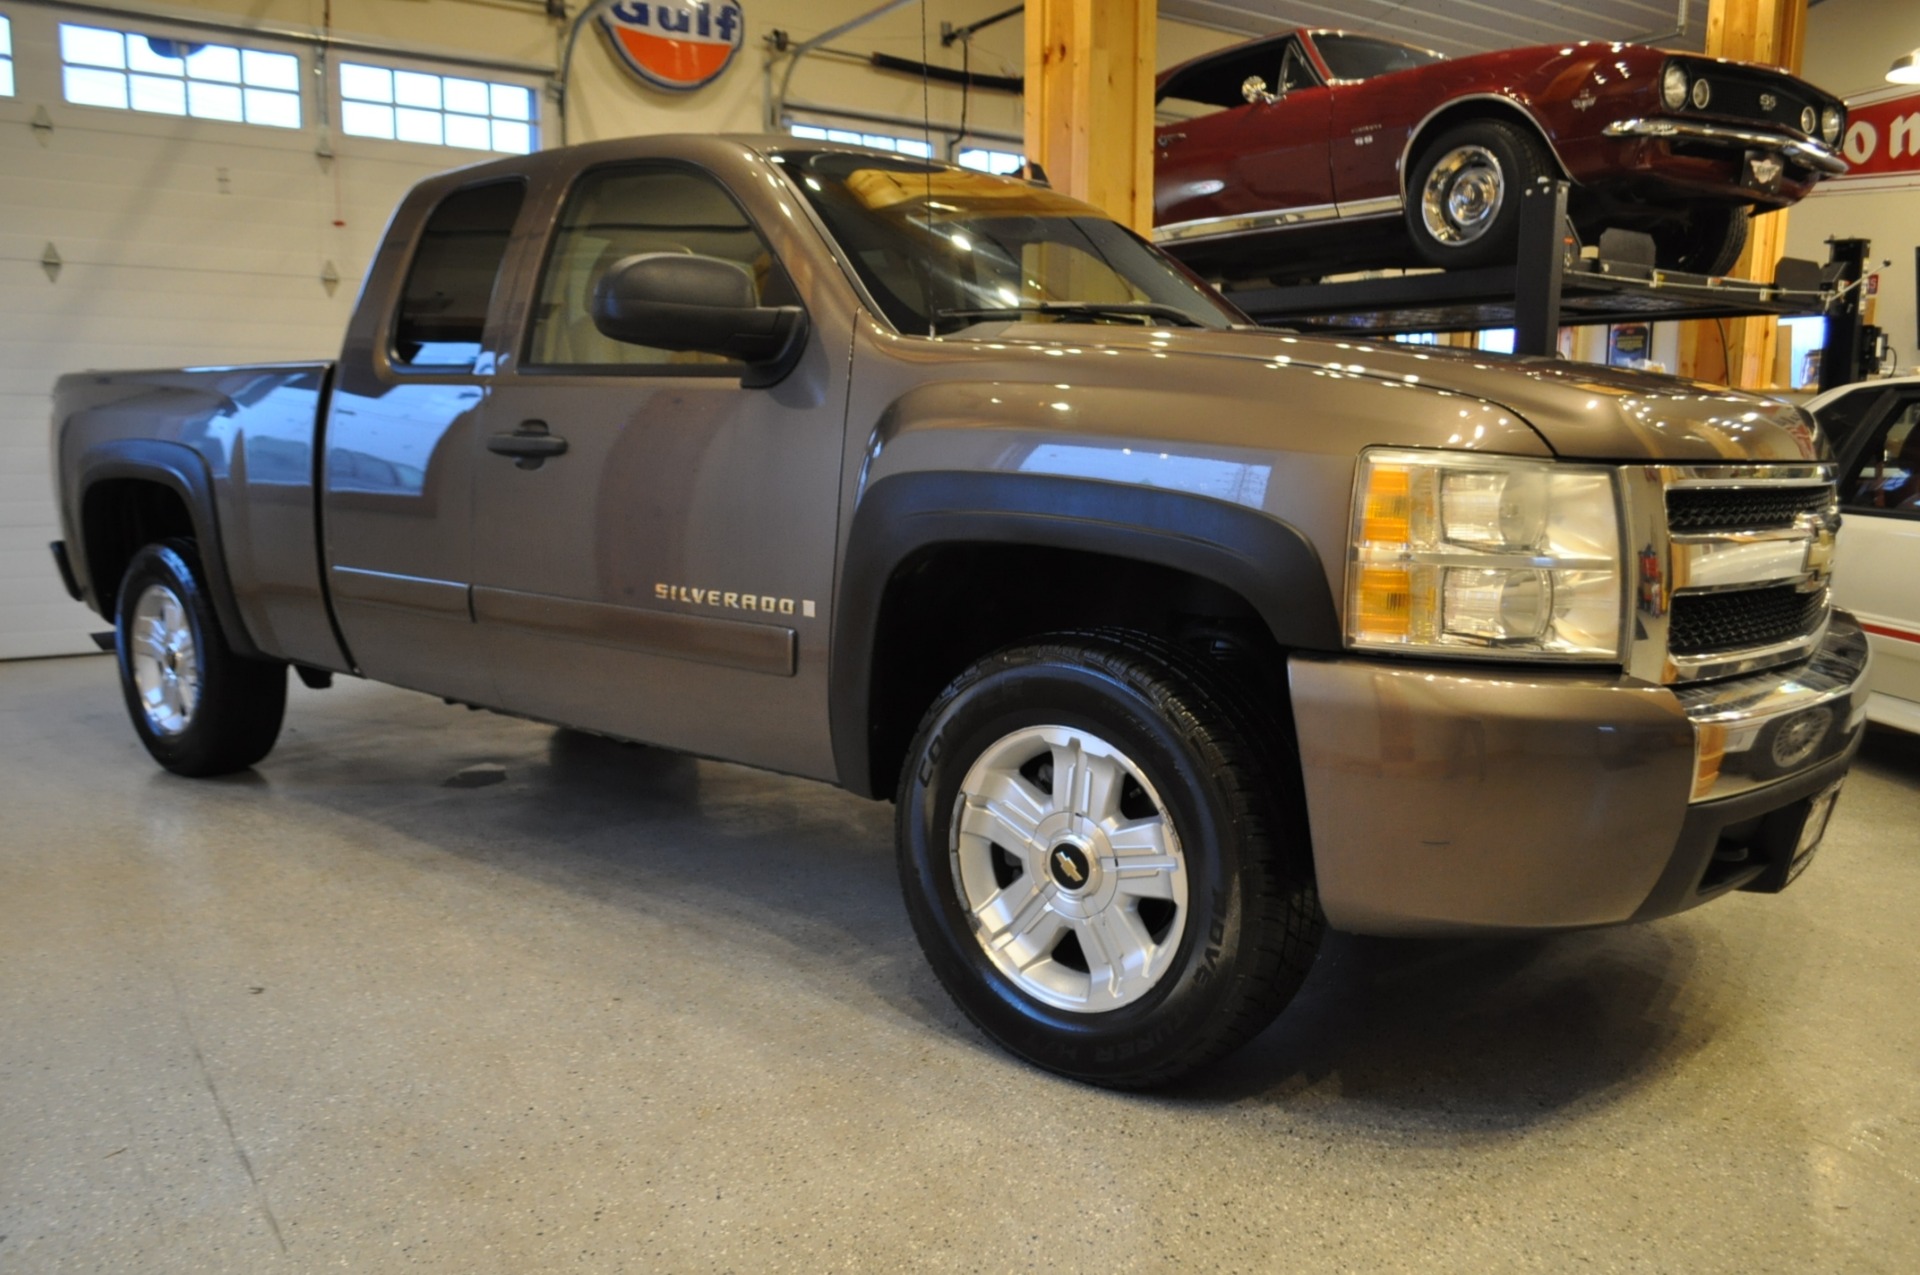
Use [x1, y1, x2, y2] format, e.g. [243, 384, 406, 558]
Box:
[774, 152, 1246, 336]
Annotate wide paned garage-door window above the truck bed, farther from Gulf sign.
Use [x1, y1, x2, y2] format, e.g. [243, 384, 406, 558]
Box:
[60, 23, 300, 129]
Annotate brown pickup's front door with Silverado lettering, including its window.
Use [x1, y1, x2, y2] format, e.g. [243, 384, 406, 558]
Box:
[474, 161, 847, 778]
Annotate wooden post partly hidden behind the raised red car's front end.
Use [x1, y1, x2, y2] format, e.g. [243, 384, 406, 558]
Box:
[1676, 0, 1807, 390]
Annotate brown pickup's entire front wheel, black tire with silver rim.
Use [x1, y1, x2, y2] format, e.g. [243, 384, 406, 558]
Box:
[897, 634, 1323, 1089]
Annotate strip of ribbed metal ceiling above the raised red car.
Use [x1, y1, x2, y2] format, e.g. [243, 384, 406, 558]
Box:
[1160, 0, 1707, 56]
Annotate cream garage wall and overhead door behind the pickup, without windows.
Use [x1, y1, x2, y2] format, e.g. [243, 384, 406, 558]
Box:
[0, 0, 1233, 659]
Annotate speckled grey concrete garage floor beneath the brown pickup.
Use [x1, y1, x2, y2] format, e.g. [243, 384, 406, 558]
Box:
[0, 657, 1920, 1275]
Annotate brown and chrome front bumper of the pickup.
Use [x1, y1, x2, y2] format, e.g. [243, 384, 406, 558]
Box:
[1288, 613, 1868, 935]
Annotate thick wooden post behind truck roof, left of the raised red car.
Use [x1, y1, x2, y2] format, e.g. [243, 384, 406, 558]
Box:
[1025, 0, 1152, 234]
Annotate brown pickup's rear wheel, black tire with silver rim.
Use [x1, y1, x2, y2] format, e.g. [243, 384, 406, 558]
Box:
[113, 540, 286, 778]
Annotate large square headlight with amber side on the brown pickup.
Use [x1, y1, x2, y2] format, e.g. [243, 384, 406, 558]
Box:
[1346, 449, 1624, 661]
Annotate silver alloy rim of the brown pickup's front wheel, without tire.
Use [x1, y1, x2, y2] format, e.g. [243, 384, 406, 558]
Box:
[948, 726, 1187, 1014]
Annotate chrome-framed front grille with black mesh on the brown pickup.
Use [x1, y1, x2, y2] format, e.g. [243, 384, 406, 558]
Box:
[1624, 465, 1839, 684]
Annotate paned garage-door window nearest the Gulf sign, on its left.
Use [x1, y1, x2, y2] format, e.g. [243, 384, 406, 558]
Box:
[340, 61, 540, 156]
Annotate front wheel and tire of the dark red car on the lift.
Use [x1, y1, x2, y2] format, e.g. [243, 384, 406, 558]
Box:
[1405, 119, 1557, 271]
